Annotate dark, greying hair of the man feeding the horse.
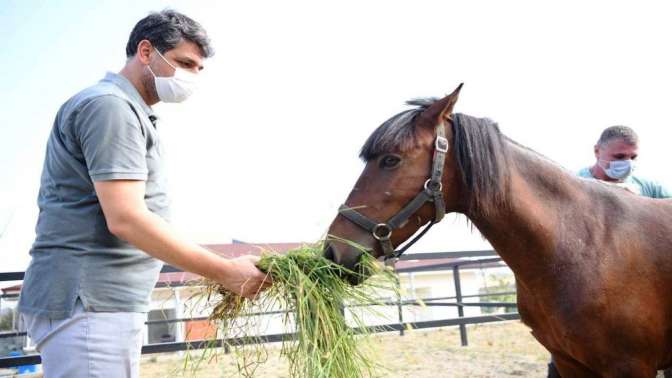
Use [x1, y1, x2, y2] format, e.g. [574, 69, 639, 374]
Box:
[126, 9, 215, 58]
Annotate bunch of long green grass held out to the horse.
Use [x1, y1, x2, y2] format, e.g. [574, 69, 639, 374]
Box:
[200, 246, 396, 378]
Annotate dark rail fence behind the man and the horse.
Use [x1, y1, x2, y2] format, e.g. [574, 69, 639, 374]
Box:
[0, 250, 520, 368]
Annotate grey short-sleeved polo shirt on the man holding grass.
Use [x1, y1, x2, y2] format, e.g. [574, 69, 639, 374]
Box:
[19, 73, 169, 319]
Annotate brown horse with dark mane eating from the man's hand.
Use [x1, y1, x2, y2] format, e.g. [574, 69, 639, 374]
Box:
[325, 86, 672, 377]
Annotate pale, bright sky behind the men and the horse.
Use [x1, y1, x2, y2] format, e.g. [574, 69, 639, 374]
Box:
[0, 0, 672, 271]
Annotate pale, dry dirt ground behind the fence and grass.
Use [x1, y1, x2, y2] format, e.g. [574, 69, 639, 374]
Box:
[141, 321, 549, 378]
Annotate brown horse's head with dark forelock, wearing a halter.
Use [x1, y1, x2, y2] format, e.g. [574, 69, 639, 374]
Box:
[325, 85, 472, 282]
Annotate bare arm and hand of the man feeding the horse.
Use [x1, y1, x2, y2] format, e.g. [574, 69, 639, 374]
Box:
[94, 180, 270, 297]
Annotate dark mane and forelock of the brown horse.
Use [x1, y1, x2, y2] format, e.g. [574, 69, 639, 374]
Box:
[360, 98, 510, 215]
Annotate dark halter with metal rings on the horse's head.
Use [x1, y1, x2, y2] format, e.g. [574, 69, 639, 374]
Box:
[338, 118, 457, 260]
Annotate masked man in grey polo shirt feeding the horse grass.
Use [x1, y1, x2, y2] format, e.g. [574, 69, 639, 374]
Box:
[19, 10, 270, 378]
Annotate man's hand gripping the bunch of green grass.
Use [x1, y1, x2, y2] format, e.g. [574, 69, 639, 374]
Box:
[217, 255, 273, 299]
